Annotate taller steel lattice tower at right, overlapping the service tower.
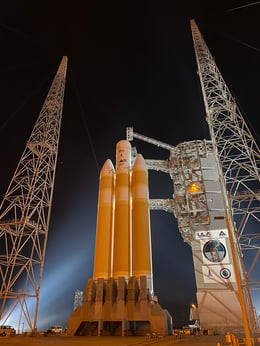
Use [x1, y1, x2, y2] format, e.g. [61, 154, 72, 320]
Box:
[191, 20, 260, 289]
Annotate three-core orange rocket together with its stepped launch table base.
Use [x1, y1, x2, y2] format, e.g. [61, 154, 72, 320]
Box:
[68, 140, 172, 335]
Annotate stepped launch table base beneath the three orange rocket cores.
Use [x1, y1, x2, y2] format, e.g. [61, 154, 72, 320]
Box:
[67, 276, 172, 336]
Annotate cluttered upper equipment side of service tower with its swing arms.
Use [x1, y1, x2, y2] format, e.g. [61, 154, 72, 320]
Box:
[126, 127, 212, 238]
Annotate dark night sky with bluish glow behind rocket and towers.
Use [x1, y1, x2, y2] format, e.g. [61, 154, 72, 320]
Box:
[0, 0, 260, 329]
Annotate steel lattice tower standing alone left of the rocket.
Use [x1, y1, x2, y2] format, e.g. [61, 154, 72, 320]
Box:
[0, 57, 67, 332]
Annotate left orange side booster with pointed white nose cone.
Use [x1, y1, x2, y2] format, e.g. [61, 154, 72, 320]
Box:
[93, 160, 115, 280]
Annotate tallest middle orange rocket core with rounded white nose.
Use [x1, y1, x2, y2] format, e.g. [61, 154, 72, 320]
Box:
[113, 140, 131, 279]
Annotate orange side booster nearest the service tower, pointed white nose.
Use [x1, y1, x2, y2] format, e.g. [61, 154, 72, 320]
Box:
[132, 154, 153, 293]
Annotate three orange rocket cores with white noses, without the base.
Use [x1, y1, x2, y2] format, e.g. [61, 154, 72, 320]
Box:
[93, 140, 153, 294]
